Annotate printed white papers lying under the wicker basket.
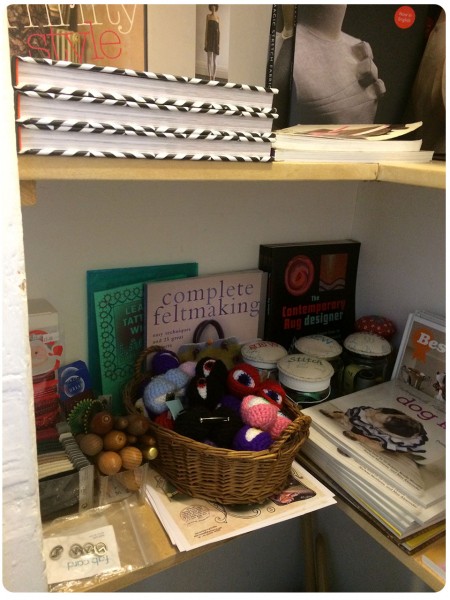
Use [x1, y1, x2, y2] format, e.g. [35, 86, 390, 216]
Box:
[146, 461, 336, 551]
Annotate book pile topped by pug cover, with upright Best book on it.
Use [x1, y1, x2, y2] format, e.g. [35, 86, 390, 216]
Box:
[300, 311, 446, 553]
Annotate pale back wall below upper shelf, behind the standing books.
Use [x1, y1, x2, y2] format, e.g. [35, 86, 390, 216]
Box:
[22, 182, 357, 362]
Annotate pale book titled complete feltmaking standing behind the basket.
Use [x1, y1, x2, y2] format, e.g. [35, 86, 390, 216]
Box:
[145, 269, 267, 352]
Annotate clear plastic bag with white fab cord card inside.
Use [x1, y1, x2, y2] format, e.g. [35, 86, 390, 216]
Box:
[43, 495, 159, 592]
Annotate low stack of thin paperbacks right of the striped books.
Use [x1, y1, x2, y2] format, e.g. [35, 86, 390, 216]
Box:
[274, 121, 433, 163]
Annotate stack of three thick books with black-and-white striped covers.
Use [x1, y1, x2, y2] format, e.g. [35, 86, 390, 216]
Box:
[12, 56, 277, 162]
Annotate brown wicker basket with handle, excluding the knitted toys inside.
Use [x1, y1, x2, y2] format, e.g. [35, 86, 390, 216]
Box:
[124, 346, 311, 504]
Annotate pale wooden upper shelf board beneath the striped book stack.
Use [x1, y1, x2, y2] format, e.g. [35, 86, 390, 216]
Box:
[18, 155, 446, 204]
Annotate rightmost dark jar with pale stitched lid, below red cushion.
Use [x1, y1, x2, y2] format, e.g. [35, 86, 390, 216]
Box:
[341, 332, 392, 395]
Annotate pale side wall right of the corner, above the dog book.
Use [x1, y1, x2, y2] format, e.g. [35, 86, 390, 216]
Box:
[352, 183, 446, 352]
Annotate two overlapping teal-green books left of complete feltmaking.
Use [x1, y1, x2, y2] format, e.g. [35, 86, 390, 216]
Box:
[86, 262, 198, 412]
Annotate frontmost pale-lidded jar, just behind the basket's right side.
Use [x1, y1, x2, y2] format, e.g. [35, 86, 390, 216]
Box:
[278, 354, 334, 406]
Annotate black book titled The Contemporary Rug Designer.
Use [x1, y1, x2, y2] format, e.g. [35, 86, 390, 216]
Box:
[258, 239, 361, 350]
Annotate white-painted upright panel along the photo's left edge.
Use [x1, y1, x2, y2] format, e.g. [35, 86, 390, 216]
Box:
[0, 11, 47, 592]
